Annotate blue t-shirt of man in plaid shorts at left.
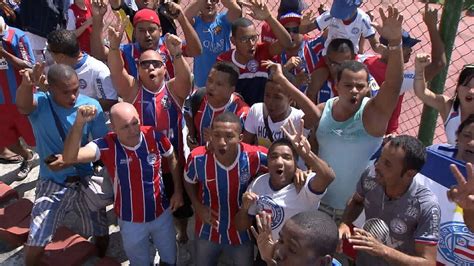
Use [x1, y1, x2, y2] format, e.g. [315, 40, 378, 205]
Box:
[28, 92, 108, 184]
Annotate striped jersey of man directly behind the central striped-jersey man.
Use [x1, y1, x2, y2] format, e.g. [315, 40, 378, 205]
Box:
[193, 93, 250, 145]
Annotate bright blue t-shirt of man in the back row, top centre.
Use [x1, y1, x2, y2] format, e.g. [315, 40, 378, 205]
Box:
[193, 13, 231, 87]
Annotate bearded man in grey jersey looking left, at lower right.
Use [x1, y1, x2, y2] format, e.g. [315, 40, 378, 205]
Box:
[339, 135, 441, 265]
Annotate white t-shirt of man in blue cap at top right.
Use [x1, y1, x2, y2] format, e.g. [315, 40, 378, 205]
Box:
[316, 8, 375, 55]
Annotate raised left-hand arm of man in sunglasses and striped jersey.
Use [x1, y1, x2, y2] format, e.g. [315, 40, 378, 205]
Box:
[107, 23, 138, 102]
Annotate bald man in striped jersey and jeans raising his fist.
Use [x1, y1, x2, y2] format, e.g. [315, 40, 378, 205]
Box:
[63, 102, 183, 265]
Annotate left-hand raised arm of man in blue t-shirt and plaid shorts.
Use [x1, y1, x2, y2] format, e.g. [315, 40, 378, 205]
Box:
[16, 63, 45, 115]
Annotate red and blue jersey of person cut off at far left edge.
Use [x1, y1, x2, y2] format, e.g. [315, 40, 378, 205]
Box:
[0, 27, 35, 104]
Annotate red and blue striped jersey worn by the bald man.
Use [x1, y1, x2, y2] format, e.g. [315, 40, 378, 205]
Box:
[94, 126, 173, 223]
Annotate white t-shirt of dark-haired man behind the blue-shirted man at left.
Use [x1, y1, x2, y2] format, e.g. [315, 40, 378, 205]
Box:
[74, 53, 117, 100]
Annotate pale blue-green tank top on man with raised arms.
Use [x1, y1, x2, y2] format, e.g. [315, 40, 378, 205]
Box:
[316, 97, 382, 209]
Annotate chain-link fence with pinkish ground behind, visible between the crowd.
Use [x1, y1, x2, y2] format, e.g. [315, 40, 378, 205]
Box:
[105, 0, 474, 143]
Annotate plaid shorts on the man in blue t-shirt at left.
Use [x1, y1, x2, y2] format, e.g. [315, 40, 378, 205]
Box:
[27, 179, 108, 247]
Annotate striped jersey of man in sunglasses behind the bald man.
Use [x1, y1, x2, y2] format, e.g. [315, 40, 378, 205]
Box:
[132, 82, 184, 173]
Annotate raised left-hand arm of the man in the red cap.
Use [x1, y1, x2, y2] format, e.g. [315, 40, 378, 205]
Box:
[91, 0, 109, 61]
